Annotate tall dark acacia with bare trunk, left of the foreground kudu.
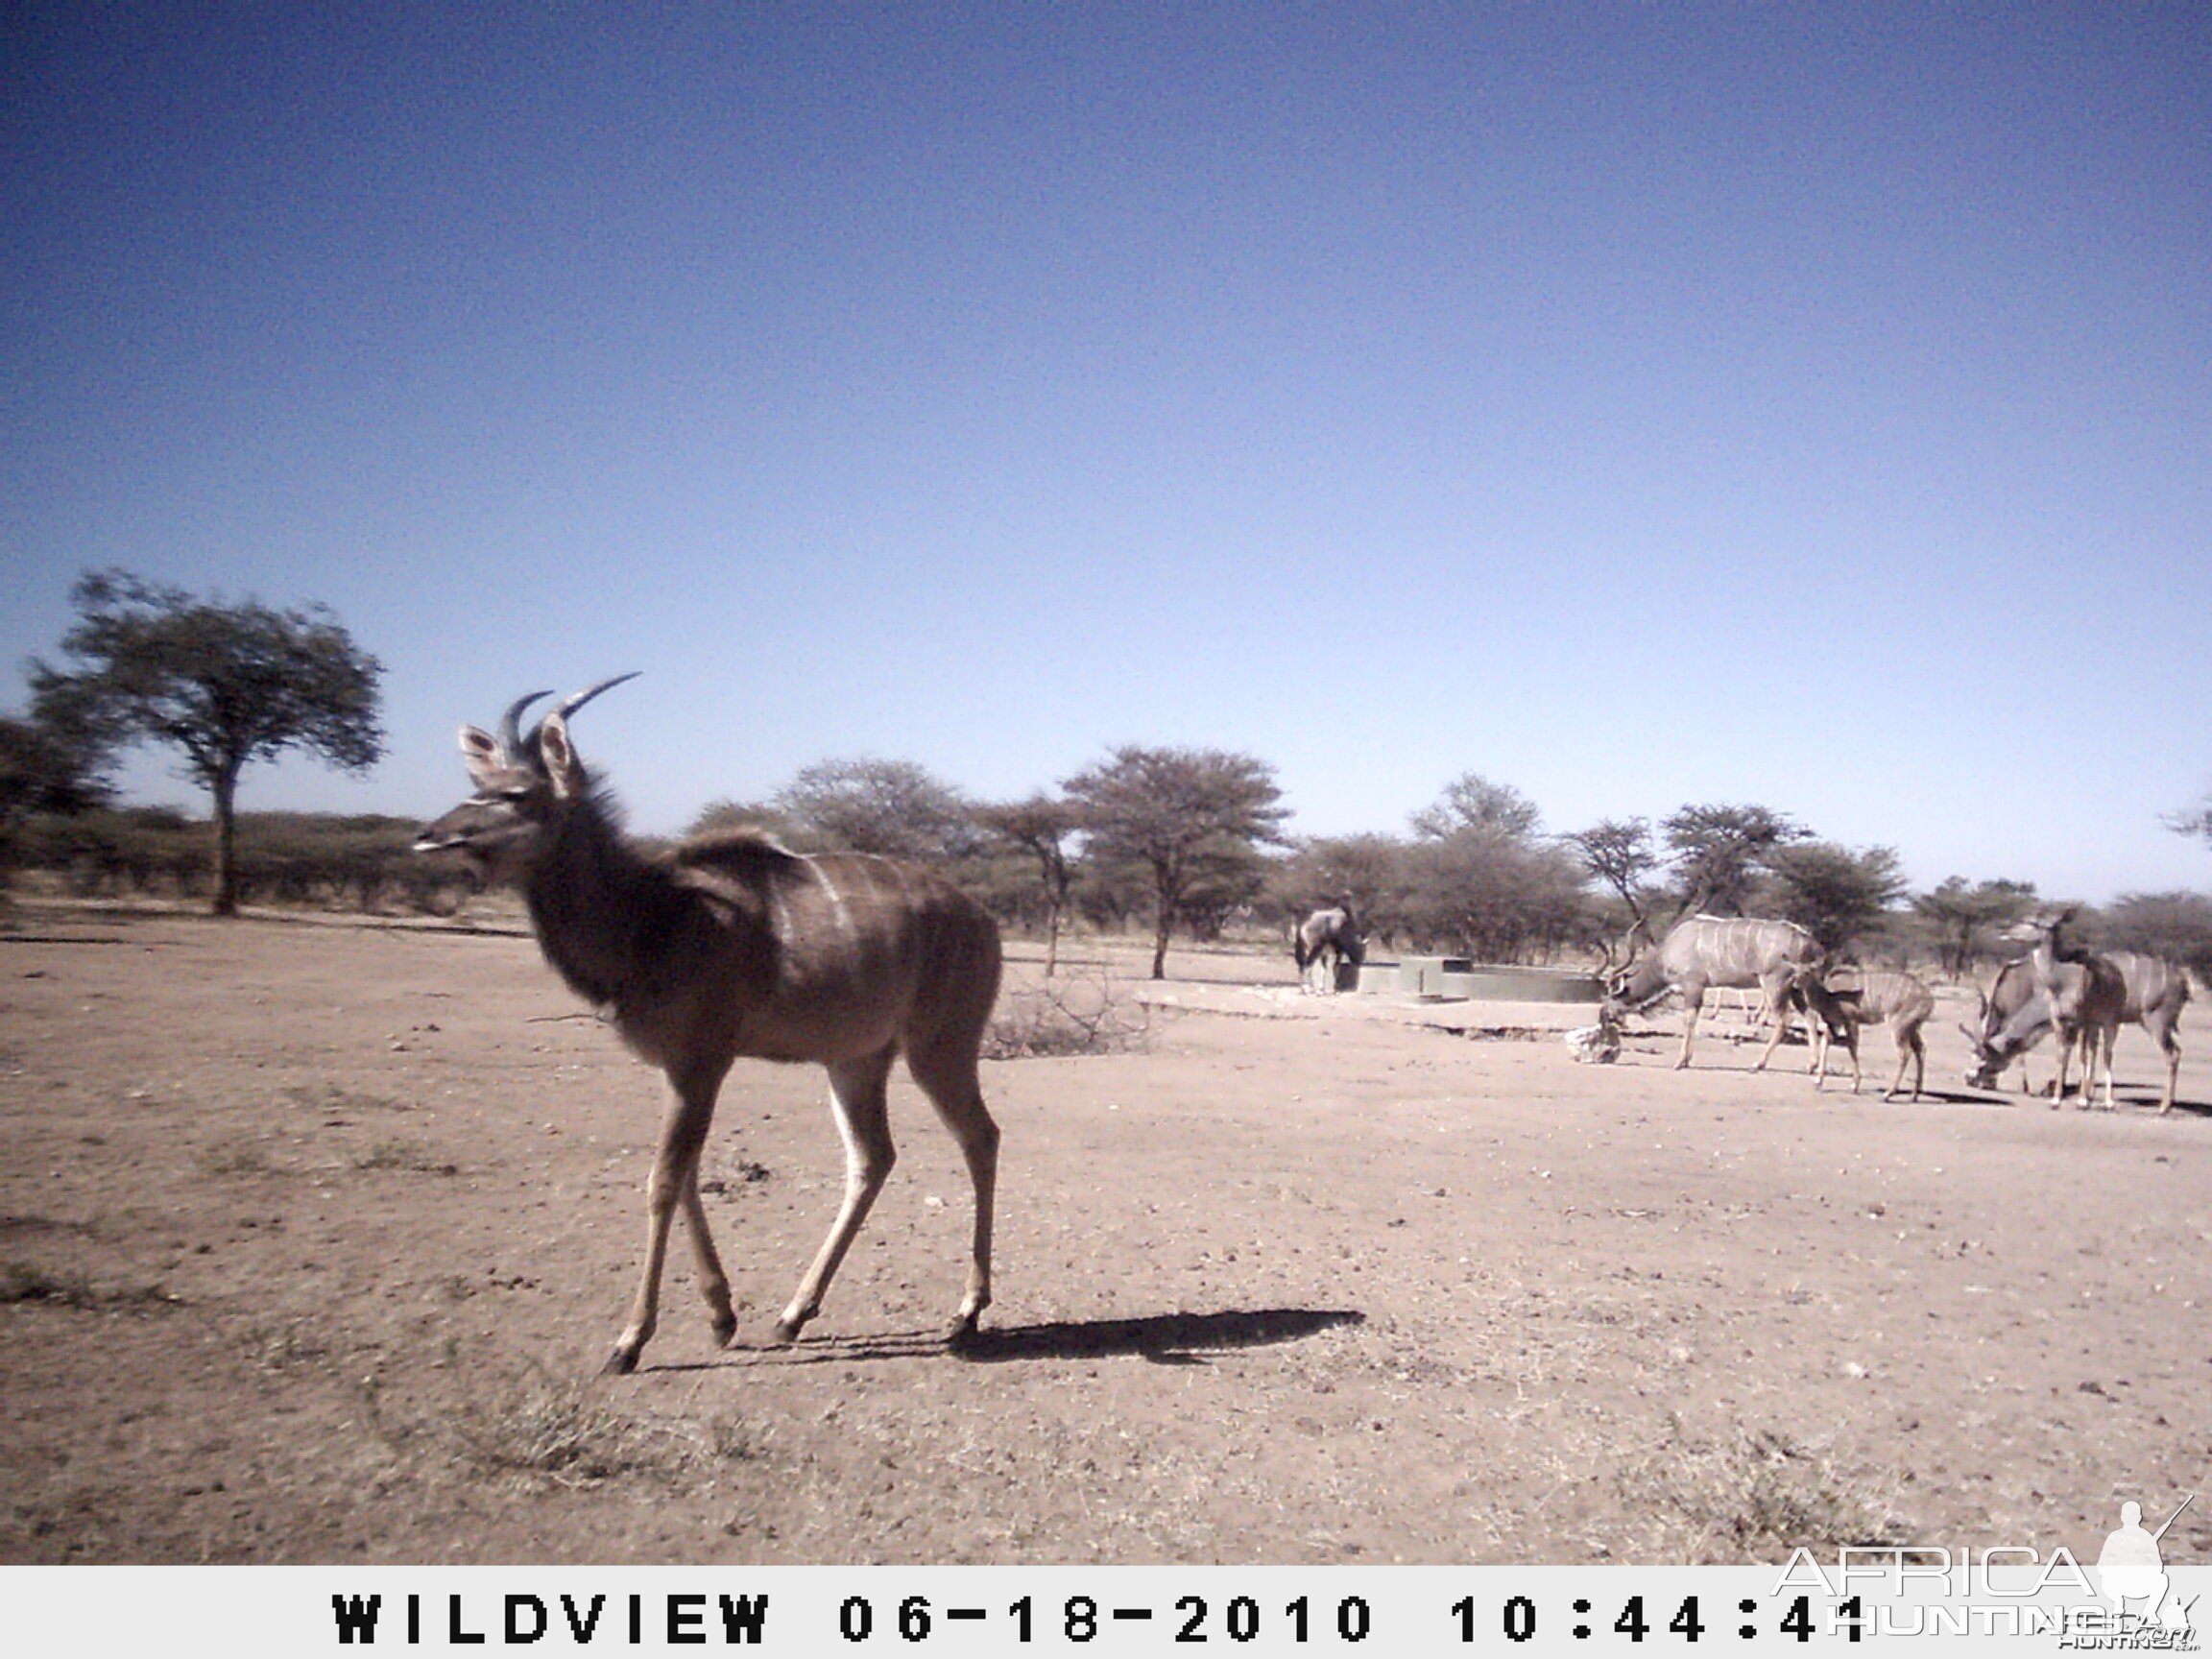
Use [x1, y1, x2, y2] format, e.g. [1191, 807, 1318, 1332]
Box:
[31, 570, 385, 916]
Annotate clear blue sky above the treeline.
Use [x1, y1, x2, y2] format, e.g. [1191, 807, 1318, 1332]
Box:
[0, 5, 2212, 901]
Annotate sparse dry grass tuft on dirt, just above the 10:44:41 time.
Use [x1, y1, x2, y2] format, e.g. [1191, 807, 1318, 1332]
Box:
[1617, 1416, 1902, 1566]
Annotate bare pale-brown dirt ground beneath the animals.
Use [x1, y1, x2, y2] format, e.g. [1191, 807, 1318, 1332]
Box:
[0, 907, 2212, 1564]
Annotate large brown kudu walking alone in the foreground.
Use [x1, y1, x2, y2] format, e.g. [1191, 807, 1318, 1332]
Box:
[416, 675, 999, 1374]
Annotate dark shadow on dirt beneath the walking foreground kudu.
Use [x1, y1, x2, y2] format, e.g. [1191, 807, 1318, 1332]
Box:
[703, 1308, 1367, 1369]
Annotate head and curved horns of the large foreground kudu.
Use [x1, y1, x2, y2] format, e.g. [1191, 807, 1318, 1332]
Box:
[414, 672, 637, 882]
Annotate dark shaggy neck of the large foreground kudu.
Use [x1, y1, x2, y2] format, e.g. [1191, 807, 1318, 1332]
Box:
[522, 790, 682, 1006]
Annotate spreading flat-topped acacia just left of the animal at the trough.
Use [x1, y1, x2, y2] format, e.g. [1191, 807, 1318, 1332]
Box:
[1060, 743, 1289, 980]
